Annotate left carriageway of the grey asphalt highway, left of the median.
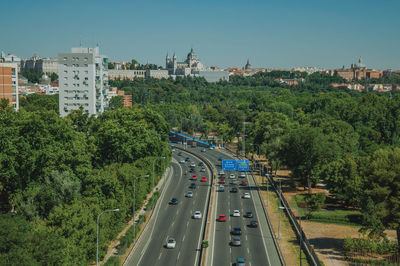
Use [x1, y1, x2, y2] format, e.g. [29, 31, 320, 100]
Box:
[124, 150, 211, 266]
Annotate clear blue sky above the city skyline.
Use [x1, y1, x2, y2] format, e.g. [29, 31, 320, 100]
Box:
[0, 0, 400, 69]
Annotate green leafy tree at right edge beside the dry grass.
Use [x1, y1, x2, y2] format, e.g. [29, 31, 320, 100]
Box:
[363, 147, 400, 251]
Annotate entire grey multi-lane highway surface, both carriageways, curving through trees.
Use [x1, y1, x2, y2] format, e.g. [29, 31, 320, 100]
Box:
[125, 145, 282, 266]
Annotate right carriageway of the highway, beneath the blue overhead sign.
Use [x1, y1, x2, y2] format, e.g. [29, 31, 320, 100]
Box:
[189, 145, 282, 266]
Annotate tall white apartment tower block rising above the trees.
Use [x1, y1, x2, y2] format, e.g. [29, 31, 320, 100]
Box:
[58, 46, 108, 116]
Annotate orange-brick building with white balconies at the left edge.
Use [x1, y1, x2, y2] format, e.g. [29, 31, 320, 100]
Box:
[0, 63, 19, 110]
